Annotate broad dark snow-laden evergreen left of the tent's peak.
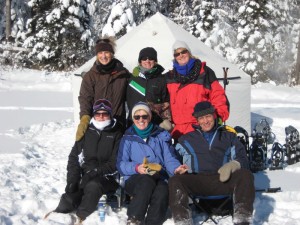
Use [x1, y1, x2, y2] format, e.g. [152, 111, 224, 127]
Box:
[24, 0, 94, 70]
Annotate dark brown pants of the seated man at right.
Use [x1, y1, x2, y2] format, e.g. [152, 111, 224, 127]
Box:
[169, 169, 255, 224]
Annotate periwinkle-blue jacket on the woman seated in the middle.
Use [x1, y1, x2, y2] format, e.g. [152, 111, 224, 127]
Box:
[117, 125, 180, 181]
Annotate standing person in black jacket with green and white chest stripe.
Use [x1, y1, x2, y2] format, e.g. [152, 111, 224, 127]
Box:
[126, 47, 172, 131]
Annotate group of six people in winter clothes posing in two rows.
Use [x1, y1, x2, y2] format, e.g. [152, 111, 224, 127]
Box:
[50, 37, 255, 225]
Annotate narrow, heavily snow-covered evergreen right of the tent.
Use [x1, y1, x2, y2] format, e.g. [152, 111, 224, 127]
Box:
[237, 0, 272, 83]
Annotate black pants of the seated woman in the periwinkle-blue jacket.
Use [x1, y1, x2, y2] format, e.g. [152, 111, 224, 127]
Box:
[125, 174, 168, 225]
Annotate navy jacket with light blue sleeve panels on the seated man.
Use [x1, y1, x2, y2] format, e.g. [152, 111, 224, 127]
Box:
[176, 126, 249, 173]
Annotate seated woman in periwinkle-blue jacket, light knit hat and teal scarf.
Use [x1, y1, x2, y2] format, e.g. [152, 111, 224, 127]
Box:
[117, 102, 187, 225]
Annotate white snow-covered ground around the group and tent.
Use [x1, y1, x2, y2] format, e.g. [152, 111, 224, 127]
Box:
[0, 70, 300, 225]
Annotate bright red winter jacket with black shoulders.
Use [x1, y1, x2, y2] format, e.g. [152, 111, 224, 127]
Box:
[166, 60, 229, 139]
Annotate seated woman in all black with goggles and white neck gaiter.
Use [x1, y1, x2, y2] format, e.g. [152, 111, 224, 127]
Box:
[45, 99, 122, 224]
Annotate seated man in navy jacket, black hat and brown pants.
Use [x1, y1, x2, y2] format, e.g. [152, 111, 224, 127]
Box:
[169, 101, 255, 225]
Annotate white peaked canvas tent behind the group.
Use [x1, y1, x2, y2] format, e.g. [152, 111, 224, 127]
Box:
[73, 13, 251, 132]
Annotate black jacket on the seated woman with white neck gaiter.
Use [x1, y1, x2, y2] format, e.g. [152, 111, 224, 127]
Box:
[67, 121, 122, 183]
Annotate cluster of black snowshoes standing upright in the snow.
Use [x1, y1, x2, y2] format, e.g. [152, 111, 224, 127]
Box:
[234, 119, 300, 172]
